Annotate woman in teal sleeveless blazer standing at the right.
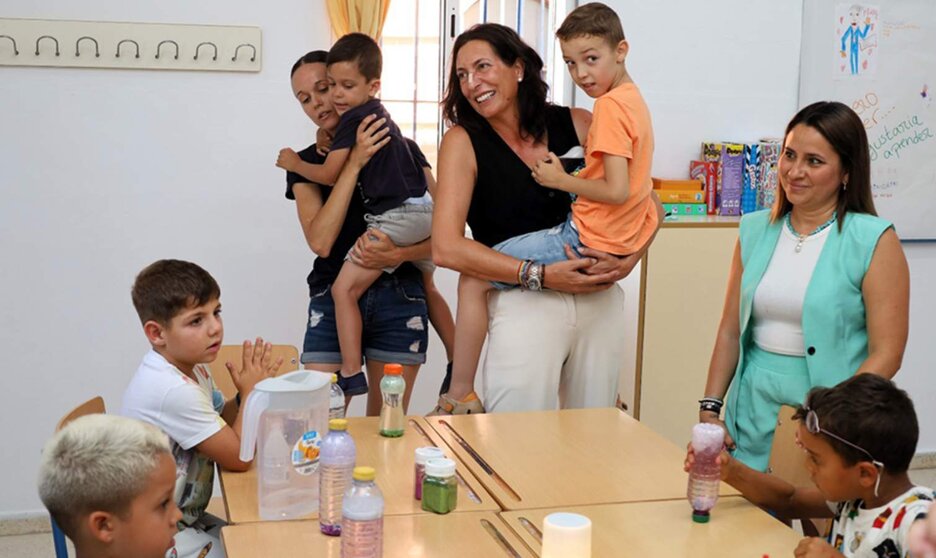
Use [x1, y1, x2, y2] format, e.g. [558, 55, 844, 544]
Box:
[699, 102, 910, 471]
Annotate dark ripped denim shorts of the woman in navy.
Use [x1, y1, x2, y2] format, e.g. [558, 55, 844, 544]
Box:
[300, 275, 429, 364]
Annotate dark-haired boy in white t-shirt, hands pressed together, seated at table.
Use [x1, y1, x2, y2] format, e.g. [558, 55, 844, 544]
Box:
[121, 260, 282, 558]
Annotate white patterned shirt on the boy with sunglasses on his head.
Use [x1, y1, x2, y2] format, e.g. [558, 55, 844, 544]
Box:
[829, 486, 934, 558]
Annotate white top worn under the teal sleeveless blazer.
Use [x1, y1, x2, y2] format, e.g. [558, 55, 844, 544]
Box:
[751, 223, 836, 356]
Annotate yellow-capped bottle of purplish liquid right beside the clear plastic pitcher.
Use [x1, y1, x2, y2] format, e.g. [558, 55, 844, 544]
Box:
[319, 420, 357, 537]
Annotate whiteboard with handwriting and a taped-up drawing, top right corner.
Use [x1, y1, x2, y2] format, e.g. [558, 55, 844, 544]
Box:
[799, 0, 936, 239]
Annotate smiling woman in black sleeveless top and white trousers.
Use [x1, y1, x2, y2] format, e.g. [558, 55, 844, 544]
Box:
[432, 24, 662, 411]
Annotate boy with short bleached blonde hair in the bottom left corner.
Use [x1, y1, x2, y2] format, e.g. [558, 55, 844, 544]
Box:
[39, 415, 182, 558]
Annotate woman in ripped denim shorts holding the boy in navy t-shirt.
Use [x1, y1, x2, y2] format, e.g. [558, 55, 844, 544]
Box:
[277, 51, 441, 415]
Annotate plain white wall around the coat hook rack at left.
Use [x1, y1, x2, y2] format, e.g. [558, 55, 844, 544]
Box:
[0, 0, 330, 516]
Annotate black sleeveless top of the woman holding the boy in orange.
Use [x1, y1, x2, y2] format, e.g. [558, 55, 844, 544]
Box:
[466, 105, 579, 246]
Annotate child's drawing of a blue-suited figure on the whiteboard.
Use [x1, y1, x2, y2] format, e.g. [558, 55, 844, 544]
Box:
[834, 4, 880, 79]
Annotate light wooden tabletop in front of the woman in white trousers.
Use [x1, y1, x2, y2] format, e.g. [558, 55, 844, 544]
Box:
[425, 408, 738, 510]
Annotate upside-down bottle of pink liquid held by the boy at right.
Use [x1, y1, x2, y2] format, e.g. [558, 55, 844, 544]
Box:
[686, 422, 725, 523]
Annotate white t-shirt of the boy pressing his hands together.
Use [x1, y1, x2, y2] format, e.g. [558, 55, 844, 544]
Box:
[120, 350, 225, 529]
